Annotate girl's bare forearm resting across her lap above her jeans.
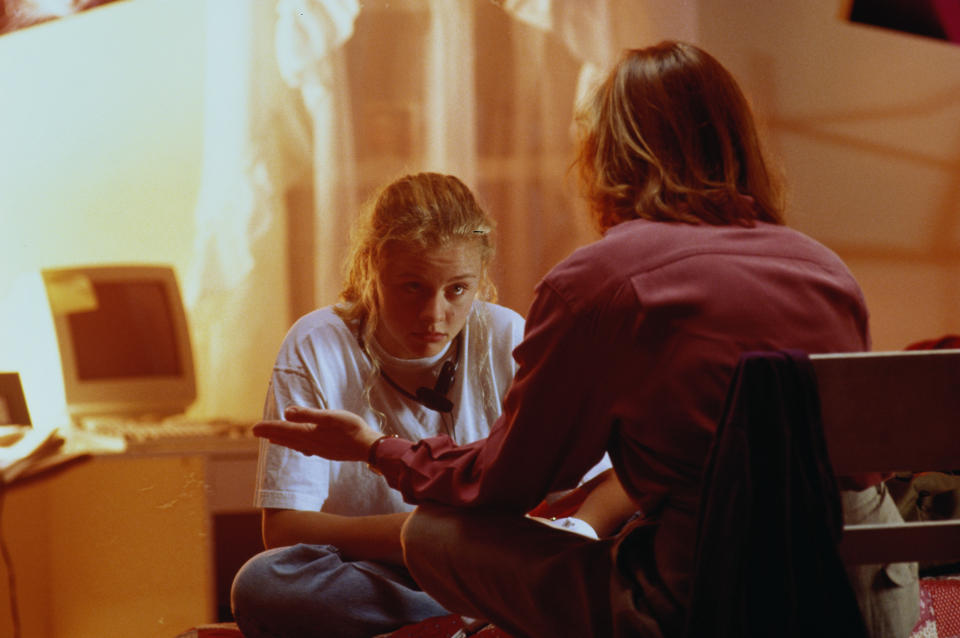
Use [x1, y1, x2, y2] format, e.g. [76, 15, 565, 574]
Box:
[262, 508, 409, 565]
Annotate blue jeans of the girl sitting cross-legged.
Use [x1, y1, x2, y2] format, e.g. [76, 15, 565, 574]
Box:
[230, 544, 449, 638]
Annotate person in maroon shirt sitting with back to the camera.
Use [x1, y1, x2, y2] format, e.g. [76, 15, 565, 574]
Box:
[254, 42, 917, 638]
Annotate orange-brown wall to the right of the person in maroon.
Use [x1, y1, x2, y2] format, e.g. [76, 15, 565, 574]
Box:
[699, 0, 960, 349]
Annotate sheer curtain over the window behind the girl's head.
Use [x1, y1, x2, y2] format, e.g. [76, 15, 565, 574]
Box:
[276, 0, 612, 313]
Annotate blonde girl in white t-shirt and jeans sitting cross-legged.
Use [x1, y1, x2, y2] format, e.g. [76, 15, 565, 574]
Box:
[231, 173, 625, 638]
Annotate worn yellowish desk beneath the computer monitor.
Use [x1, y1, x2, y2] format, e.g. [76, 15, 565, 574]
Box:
[0, 440, 259, 638]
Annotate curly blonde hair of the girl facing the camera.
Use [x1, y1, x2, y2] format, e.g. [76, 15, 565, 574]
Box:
[334, 173, 497, 425]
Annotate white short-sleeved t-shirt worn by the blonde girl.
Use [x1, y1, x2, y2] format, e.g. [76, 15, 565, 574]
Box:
[255, 301, 523, 516]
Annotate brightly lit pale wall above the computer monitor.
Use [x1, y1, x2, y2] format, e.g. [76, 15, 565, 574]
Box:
[0, 0, 204, 292]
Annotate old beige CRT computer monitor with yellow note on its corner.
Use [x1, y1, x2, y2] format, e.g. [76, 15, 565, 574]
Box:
[42, 264, 196, 422]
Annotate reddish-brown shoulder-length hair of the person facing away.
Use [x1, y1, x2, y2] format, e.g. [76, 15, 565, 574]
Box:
[575, 42, 783, 232]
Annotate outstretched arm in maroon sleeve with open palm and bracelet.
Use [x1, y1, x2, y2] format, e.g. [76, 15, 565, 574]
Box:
[254, 289, 618, 513]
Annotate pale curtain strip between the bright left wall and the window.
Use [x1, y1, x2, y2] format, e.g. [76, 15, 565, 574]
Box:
[181, 0, 310, 420]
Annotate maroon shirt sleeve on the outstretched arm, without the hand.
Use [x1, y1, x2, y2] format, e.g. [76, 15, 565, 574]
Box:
[373, 283, 610, 511]
